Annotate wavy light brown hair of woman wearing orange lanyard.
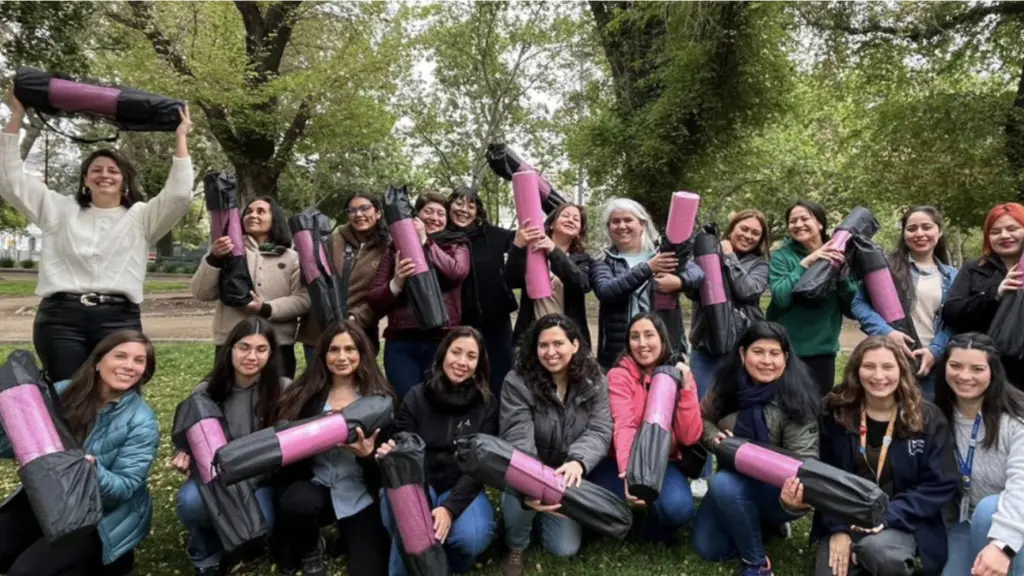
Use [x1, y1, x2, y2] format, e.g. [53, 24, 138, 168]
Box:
[825, 336, 926, 438]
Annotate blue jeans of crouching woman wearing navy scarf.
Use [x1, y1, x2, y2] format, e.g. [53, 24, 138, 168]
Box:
[691, 469, 800, 566]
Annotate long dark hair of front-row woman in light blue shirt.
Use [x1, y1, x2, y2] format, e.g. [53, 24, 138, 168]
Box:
[274, 320, 394, 421]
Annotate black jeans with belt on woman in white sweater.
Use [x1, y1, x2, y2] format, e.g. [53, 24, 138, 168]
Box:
[32, 298, 142, 382]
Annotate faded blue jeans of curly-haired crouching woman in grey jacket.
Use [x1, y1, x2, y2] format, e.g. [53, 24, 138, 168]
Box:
[502, 485, 583, 558]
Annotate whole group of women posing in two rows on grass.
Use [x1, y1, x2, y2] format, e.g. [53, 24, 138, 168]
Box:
[0, 84, 1024, 576]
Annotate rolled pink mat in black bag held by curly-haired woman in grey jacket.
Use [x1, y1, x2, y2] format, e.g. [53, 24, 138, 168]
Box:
[456, 434, 633, 540]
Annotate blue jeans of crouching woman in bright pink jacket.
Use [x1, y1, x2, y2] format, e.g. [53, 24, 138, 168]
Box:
[591, 458, 694, 542]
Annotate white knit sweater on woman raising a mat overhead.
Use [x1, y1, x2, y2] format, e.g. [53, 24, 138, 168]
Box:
[0, 133, 193, 303]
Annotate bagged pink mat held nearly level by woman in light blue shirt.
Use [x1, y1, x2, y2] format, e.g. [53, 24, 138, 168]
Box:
[214, 396, 394, 485]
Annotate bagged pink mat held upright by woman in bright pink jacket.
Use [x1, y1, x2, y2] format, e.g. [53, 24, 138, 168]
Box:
[626, 366, 683, 504]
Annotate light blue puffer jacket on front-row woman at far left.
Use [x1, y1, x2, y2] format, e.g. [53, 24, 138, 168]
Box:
[0, 380, 160, 564]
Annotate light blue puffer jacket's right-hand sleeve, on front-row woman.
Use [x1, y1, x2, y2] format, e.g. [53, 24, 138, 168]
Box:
[96, 412, 160, 502]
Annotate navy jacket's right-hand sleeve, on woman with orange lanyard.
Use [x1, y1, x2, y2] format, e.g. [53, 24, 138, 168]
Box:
[886, 408, 959, 533]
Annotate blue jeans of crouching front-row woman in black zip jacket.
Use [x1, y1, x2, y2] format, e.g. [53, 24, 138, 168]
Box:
[381, 488, 496, 576]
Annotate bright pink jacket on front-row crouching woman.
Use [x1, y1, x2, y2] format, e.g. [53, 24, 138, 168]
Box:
[608, 356, 703, 472]
